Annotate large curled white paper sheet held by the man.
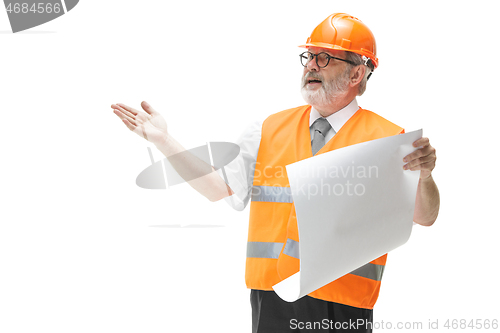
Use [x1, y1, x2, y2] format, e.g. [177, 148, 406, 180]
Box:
[273, 130, 422, 302]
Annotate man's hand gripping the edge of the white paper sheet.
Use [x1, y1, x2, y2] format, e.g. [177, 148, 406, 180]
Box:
[403, 138, 436, 179]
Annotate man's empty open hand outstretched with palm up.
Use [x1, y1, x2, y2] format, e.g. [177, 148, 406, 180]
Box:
[111, 102, 168, 145]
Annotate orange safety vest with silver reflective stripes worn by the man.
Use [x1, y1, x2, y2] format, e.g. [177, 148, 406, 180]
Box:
[245, 105, 404, 309]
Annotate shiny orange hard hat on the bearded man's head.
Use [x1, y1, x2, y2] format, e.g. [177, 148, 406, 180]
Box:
[300, 13, 378, 68]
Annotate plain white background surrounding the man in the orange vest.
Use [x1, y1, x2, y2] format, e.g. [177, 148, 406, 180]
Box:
[0, 0, 500, 333]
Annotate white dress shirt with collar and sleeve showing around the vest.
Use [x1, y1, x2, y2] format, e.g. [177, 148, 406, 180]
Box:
[217, 99, 359, 210]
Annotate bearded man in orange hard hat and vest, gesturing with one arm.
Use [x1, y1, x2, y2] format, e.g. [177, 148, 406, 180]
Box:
[112, 14, 439, 332]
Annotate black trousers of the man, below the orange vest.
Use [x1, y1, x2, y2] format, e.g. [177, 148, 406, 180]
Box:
[250, 289, 373, 333]
